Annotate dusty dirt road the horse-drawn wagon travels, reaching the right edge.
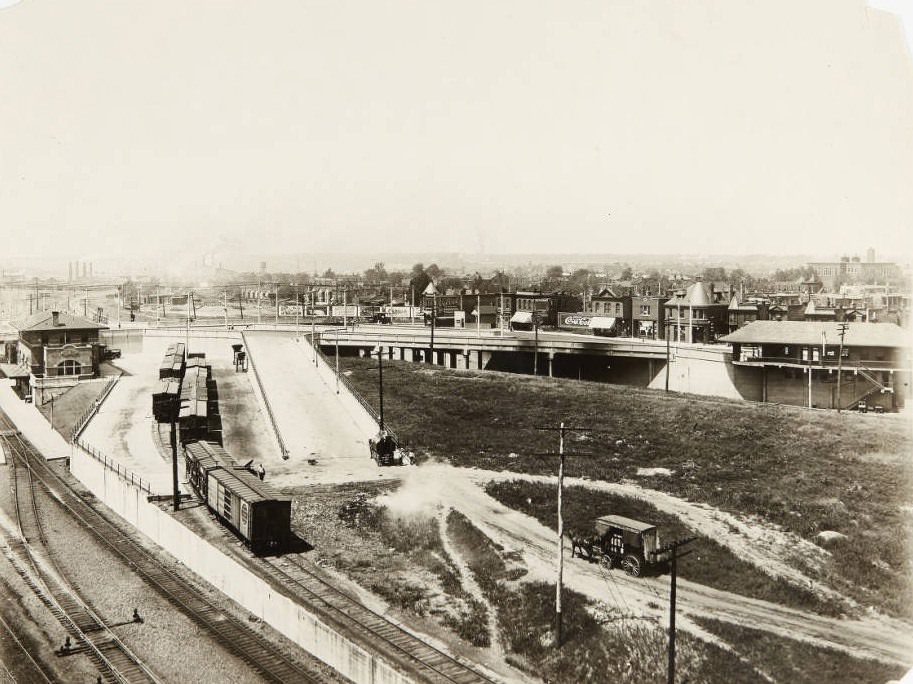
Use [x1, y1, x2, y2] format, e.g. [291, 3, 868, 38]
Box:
[405, 465, 913, 666]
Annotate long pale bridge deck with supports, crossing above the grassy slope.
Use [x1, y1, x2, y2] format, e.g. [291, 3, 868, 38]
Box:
[317, 324, 732, 368]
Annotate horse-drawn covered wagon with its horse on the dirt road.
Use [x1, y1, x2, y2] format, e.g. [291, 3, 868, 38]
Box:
[570, 515, 670, 577]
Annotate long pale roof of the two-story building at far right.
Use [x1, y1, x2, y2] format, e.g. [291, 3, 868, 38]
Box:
[720, 321, 913, 348]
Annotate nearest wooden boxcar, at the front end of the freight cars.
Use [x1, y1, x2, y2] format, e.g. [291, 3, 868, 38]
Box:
[206, 467, 292, 554]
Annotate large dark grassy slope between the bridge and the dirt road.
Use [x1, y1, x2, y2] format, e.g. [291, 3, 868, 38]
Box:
[342, 358, 913, 618]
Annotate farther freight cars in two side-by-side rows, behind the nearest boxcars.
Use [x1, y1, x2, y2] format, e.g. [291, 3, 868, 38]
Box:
[152, 342, 222, 444]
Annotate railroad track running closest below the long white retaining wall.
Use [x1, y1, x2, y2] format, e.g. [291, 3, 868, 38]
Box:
[0, 411, 326, 684]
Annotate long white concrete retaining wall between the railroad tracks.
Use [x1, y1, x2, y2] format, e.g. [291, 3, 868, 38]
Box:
[70, 446, 412, 684]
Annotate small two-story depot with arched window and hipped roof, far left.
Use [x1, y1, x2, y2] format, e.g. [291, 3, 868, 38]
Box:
[11, 311, 108, 404]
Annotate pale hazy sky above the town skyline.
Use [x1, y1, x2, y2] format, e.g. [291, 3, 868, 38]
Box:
[0, 0, 913, 272]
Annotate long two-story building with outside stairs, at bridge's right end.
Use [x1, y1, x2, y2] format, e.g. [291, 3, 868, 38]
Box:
[720, 321, 913, 411]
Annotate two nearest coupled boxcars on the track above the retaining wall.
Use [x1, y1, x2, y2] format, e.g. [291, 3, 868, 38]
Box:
[184, 441, 292, 555]
